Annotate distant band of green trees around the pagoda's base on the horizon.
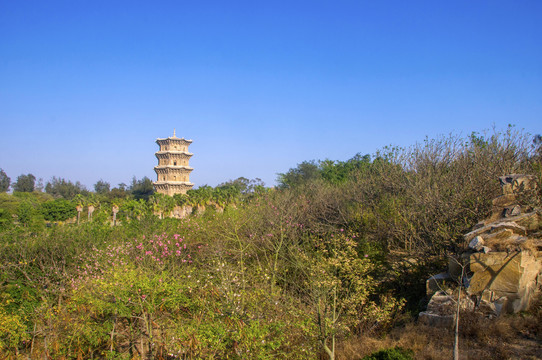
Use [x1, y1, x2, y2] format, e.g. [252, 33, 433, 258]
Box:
[0, 169, 266, 228]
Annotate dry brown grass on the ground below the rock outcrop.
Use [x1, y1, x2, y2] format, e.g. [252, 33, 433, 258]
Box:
[338, 297, 542, 360]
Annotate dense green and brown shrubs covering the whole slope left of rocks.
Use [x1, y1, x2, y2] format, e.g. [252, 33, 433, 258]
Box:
[0, 127, 542, 359]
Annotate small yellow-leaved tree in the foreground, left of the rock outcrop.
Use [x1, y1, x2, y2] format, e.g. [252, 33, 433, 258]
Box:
[292, 234, 402, 360]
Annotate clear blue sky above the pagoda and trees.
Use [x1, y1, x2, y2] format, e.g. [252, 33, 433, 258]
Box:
[0, 0, 542, 189]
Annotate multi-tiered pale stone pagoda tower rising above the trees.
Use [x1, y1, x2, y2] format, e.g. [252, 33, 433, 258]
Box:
[154, 129, 194, 196]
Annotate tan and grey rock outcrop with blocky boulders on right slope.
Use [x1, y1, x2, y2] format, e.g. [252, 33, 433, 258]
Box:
[420, 175, 542, 325]
